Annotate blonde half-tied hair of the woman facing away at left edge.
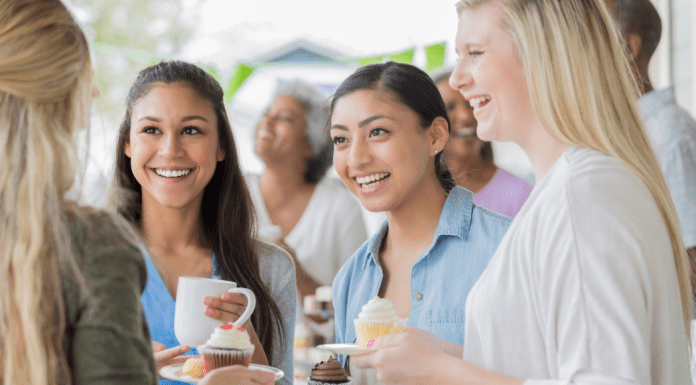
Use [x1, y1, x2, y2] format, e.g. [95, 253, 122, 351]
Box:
[0, 0, 93, 385]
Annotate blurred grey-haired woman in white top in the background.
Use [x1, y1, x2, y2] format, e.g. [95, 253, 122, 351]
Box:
[247, 80, 367, 300]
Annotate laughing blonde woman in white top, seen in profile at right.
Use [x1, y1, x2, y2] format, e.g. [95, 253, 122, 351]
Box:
[351, 0, 692, 385]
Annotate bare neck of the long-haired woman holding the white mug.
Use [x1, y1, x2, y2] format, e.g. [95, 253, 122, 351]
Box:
[140, 196, 202, 251]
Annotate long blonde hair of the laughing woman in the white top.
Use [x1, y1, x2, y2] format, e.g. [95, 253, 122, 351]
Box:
[457, 0, 693, 336]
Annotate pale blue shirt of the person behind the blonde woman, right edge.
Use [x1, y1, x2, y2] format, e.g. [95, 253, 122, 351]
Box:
[638, 87, 696, 249]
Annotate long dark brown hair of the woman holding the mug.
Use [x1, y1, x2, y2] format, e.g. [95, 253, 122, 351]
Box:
[111, 61, 287, 363]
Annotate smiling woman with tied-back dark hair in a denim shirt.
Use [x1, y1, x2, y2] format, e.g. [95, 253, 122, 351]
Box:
[331, 62, 511, 383]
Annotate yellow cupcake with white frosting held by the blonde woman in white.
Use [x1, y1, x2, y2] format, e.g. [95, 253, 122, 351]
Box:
[353, 297, 405, 349]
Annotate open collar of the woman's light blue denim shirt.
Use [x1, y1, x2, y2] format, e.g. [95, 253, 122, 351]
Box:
[367, 186, 474, 266]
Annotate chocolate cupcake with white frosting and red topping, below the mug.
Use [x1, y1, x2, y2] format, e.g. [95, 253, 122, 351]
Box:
[198, 322, 254, 373]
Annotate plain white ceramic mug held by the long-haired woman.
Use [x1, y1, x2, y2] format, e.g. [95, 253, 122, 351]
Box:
[174, 277, 256, 346]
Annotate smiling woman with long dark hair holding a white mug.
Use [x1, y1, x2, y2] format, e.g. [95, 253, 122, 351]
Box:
[112, 61, 296, 383]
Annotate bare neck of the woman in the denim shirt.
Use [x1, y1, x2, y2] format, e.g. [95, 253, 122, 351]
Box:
[385, 176, 447, 249]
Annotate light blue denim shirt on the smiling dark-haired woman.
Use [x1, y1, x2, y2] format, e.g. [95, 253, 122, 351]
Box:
[333, 187, 512, 363]
